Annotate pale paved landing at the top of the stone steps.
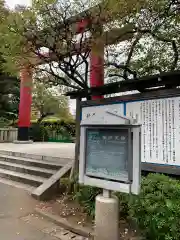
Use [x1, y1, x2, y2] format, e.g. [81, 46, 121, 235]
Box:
[0, 143, 75, 158]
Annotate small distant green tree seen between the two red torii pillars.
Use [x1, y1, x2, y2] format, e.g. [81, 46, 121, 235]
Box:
[32, 82, 71, 123]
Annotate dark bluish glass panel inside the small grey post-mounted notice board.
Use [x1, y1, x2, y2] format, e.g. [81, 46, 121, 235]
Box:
[85, 128, 129, 182]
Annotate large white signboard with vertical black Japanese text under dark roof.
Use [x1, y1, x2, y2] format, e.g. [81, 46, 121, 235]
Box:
[82, 97, 180, 165]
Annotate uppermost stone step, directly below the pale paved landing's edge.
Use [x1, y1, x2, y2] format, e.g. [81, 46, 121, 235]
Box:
[0, 155, 63, 170]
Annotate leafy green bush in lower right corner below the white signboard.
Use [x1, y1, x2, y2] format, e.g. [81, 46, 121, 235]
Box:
[128, 174, 180, 240]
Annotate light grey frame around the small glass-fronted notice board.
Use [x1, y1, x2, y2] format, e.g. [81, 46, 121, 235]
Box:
[79, 124, 141, 194]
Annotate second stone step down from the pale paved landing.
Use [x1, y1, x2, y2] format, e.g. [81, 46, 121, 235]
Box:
[0, 160, 57, 178]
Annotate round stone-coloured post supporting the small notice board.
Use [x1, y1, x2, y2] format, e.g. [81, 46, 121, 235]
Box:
[94, 189, 119, 240]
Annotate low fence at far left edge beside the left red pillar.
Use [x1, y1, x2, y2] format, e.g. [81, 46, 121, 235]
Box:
[0, 128, 18, 142]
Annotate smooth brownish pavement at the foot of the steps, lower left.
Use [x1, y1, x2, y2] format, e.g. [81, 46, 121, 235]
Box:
[0, 183, 62, 240]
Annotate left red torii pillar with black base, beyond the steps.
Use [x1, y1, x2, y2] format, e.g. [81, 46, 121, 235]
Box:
[18, 67, 33, 141]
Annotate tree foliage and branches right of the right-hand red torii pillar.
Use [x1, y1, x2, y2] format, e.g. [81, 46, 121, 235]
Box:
[107, 0, 180, 81]
